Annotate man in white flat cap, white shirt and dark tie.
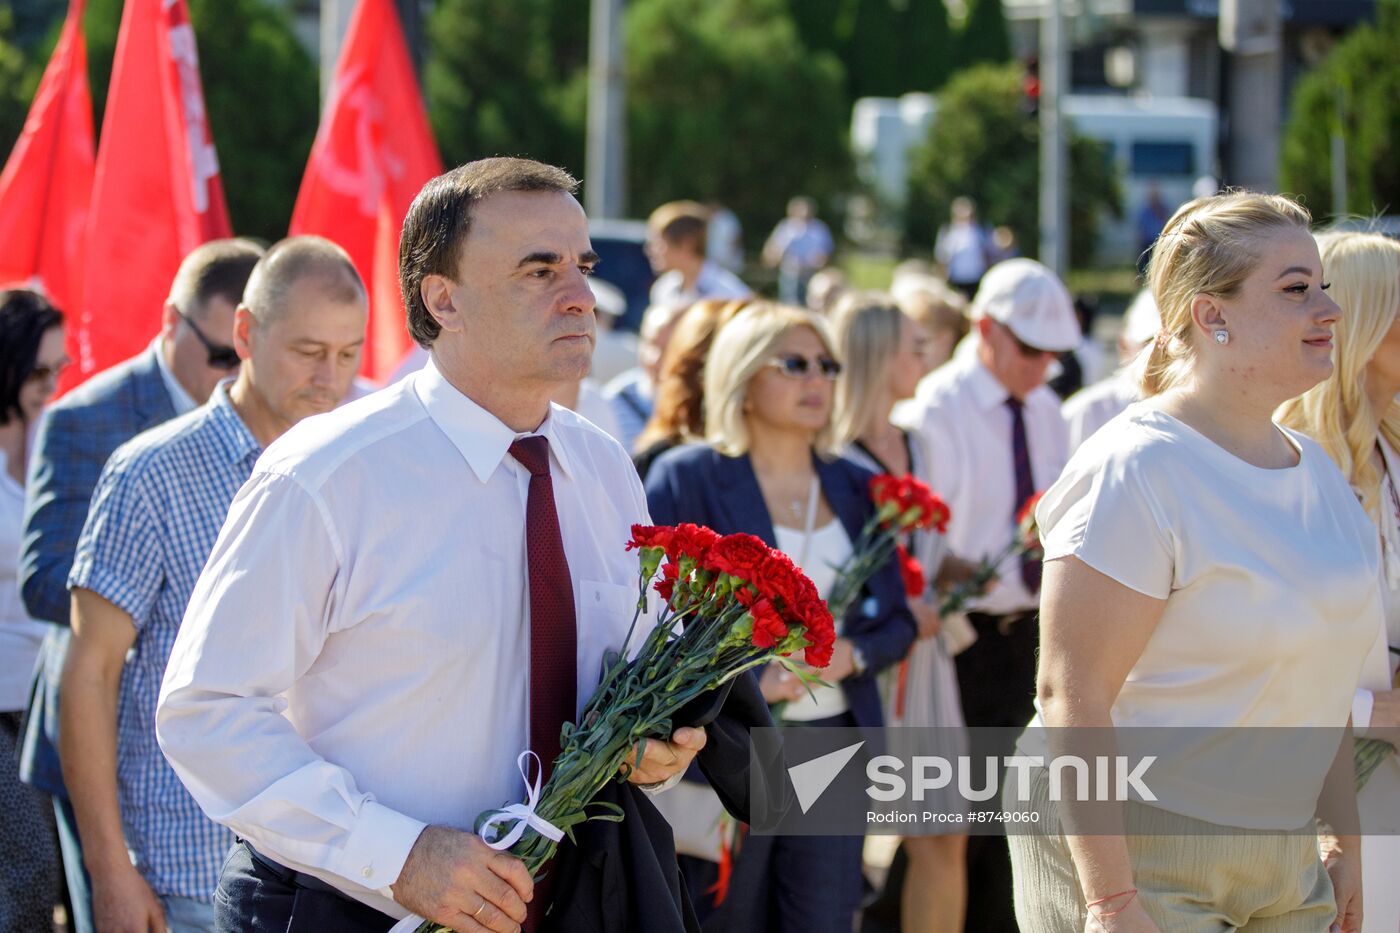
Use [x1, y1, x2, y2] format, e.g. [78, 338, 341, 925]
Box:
[896, 259, 1079, 933]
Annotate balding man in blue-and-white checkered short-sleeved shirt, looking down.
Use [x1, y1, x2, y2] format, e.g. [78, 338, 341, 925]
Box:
[60, 237, 367, 933]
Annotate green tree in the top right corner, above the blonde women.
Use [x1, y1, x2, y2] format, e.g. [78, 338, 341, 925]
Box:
[1280, 0, 1400, 219]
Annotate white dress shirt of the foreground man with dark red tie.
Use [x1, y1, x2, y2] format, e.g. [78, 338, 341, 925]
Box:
[157, 363, 655, 918]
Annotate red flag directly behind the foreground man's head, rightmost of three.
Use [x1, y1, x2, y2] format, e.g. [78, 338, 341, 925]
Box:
[291, 0, 442, 380]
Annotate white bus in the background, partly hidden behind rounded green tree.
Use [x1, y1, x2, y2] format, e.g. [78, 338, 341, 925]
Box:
[851, 94, 1219, 263]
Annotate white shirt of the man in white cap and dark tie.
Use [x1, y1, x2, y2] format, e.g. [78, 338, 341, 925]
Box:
[893, 353, 1070, 615]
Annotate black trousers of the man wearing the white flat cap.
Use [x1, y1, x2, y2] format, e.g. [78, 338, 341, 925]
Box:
[955, 612, 1039, 933]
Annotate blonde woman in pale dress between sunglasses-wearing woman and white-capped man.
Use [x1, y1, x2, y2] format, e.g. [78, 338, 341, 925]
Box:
[832, 293, 973, 933]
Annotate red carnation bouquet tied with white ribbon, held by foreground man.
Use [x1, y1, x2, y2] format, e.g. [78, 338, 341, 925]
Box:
[417, 524, 836, 933]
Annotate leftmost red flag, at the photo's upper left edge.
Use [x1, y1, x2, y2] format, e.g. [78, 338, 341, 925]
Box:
[0, 0, 92, 344]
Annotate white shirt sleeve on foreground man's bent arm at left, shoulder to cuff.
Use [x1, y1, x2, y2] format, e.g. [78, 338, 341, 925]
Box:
[155, 472, 426, 894]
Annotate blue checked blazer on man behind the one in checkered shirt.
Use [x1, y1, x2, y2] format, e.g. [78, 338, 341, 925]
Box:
[20, 349, 175, 796]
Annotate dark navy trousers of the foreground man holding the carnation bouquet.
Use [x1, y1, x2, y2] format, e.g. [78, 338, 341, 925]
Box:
[214, 841, 395, 933]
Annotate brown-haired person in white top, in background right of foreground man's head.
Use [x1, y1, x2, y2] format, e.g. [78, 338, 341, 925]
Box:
[645, 200, 753, 308]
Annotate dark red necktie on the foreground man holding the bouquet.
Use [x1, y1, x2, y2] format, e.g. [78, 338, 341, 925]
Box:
[511, 434, 578, 780]
